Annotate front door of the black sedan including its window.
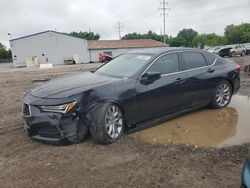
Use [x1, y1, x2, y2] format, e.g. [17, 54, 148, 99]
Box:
[136, 53, 186, 123]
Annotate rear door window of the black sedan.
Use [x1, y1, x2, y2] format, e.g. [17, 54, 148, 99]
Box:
[182, 52, 207, 70]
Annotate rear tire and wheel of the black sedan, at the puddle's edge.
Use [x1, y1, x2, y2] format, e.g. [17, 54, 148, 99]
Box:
[210, 80, 232, 109]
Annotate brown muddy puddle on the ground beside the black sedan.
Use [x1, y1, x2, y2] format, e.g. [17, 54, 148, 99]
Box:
[132, 95, 250, 147]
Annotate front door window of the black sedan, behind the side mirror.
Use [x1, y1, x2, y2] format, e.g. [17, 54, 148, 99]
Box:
[148, 53, 180, 74]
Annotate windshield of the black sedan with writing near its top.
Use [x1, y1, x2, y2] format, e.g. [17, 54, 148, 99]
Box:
[95, 53, 151, 78]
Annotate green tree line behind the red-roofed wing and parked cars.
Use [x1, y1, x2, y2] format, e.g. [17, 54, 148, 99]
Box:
[122, 23, 250, 47]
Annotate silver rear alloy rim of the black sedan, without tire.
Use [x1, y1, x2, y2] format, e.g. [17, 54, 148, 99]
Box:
[216, 83, 231, 107]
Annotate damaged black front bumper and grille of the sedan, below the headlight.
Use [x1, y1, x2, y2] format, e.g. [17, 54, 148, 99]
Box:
[22, 93, 84, 144]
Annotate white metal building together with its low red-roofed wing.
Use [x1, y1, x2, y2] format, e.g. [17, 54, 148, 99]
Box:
[10, 30, 167, 67]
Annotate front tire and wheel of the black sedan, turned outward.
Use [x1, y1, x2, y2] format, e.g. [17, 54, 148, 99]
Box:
[90, 103, 124, 144]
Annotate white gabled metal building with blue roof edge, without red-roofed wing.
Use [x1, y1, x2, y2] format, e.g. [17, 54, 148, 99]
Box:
[10, 31, 89, 67]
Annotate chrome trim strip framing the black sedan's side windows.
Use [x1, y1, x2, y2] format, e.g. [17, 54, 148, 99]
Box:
[139, 50, 218, 78]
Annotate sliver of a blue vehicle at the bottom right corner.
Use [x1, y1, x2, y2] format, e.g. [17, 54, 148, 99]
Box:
[241, 150, 250, 188]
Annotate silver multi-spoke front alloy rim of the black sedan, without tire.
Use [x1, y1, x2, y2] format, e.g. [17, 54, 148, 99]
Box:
[105, 105, 123, 139]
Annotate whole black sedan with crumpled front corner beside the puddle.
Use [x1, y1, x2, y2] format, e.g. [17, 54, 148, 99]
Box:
[22, 48, 240, 144]
